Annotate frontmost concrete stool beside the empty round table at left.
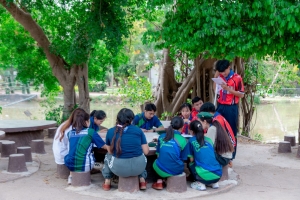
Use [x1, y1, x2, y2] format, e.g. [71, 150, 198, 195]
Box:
[7, 154, 28, 172]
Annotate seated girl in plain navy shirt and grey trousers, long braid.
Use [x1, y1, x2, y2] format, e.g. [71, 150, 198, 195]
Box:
[102, 108, 149, 191]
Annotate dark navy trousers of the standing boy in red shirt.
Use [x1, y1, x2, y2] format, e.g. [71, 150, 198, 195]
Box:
[217, 104, 239, 159]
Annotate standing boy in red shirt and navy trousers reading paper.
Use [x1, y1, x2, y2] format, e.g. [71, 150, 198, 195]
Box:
[214, 60, 244, 159]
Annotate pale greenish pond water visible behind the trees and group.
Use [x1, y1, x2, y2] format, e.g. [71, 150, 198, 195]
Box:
[0, 96, 300, 143]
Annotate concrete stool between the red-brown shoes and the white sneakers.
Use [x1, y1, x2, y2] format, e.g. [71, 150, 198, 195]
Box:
[167, 172, 187, 193]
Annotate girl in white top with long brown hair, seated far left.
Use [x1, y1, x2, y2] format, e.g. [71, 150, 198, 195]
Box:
[52, 108, 85, 184]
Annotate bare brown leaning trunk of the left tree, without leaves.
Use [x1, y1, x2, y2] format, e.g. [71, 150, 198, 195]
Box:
[0, 0, 89, 117]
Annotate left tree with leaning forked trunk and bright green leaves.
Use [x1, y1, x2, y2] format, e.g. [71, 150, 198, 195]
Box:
[0, 0, 143, 115]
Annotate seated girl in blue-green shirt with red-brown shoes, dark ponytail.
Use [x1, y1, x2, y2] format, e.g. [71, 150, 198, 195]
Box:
[152, 116, 188, 190]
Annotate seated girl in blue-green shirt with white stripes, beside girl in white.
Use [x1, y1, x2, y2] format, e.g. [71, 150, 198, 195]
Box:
[64, 109, 106, 175]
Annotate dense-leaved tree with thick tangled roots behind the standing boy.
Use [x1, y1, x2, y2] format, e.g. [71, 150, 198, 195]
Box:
[145, 0, 300, 132]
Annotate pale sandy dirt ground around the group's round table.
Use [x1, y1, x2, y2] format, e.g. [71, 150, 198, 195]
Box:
[0, 137, 300, 200]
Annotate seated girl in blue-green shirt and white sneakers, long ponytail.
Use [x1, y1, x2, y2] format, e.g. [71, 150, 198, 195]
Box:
[188, 121, 222, 191]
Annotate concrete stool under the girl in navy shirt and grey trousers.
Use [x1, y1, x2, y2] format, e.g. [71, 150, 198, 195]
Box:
[118, 176, 140, 193]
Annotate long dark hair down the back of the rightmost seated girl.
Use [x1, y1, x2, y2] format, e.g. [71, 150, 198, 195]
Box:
[212, 120, 234, 155]
